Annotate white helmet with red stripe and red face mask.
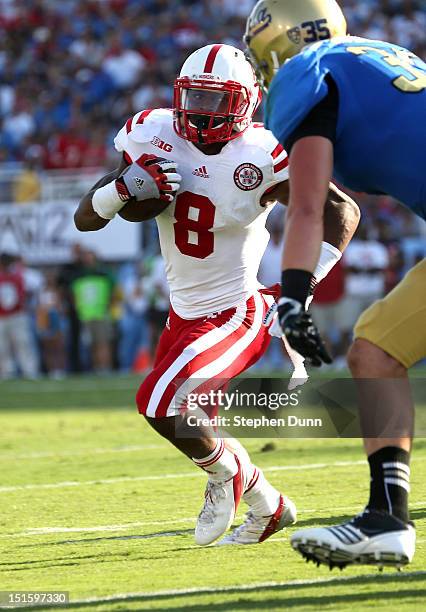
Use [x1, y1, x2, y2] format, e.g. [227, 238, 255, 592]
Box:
[174, 45, 262, 144]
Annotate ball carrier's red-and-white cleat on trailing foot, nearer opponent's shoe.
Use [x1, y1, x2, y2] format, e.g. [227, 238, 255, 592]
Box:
[218, 495, 297, 546]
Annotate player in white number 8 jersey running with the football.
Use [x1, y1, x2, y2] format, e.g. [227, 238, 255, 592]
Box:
[75, 44, 359, 545]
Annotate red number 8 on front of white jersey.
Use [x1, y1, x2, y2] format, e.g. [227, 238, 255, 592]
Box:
[174, 191, 216, 259]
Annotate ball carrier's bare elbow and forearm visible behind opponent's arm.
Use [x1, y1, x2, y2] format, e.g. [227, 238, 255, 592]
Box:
[324, 184, 361, 253]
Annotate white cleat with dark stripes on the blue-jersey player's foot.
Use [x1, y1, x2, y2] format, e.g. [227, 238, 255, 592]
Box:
[290, 510, 416, 569]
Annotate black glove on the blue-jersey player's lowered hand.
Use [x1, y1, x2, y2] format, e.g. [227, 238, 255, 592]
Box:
[278, 297, 333, 367]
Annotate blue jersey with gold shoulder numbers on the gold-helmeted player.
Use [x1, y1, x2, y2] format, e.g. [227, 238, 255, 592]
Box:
[266, 37, 426, 219]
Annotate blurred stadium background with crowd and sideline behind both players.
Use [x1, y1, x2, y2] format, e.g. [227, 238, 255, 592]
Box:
[0, 0, 426, 378]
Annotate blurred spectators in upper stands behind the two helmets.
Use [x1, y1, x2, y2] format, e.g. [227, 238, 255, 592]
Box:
[0, 0, 426, 169]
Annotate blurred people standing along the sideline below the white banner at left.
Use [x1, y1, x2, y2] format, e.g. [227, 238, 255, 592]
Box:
[0, 245, 169, 379]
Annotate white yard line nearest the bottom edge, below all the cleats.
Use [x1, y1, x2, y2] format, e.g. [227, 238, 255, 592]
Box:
[24, 570, 426, 607]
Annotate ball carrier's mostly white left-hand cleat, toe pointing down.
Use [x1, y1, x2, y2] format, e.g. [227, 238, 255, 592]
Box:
[195, 456, 244, 546]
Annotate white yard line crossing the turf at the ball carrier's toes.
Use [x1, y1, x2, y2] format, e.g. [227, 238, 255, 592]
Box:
[0, 500, 426, 548]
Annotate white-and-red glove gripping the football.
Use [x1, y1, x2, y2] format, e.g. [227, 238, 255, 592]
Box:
[115, 154, 182, 202]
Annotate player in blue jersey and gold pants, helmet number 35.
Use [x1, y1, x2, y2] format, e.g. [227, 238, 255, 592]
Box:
[245, 0, 426, 567]
